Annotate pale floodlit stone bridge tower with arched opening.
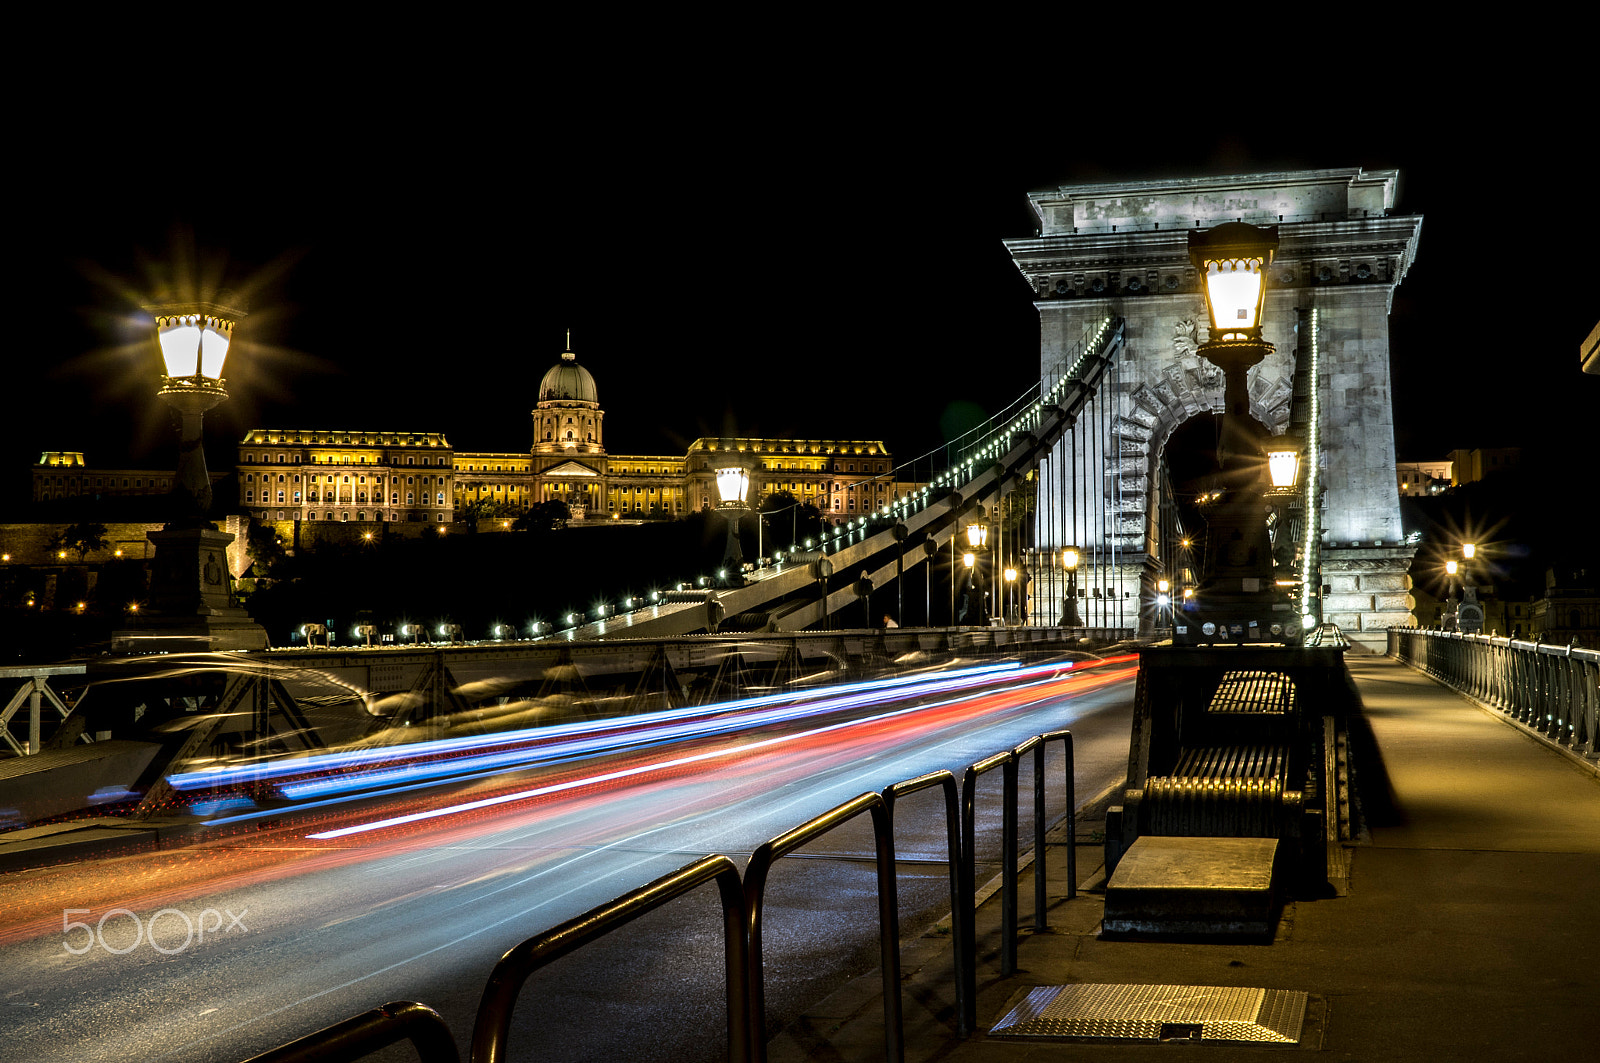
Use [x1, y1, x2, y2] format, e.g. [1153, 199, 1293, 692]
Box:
[1006, 168, 1422, 648]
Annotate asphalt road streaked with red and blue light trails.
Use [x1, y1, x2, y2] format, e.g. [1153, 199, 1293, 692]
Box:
[0, 668, 1133, 1063]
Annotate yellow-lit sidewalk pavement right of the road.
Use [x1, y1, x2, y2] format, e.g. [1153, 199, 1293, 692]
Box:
[768, 656, 1600, 1063]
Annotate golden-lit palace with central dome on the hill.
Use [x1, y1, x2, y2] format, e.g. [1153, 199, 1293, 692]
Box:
[237, 344, 920, 532]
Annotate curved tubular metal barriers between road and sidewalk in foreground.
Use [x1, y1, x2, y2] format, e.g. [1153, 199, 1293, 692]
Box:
[240, 730, 1077, 1063]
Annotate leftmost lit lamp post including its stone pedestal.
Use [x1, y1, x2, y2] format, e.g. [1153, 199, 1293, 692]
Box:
[112, 294, 267, 650]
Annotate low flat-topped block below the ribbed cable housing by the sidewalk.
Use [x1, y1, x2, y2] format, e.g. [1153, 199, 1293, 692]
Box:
[1104, 836, 1280, 938]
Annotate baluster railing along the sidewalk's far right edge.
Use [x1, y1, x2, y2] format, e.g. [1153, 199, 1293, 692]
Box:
[1389, 628, 1600, 759]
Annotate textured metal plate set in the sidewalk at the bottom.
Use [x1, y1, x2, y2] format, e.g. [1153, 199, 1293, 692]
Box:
[989, 985, 1307, 1044]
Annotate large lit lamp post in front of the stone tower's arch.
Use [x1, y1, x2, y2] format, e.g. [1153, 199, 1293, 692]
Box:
[1174, 223, 1299, 642]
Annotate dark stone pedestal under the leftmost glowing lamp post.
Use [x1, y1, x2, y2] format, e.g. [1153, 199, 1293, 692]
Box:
[112, 525, 267, 653]
